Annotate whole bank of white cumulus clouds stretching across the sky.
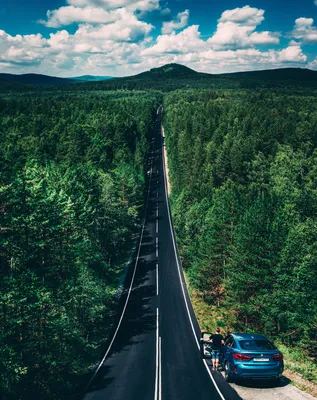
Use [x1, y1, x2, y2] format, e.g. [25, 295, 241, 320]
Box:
[0, 0, 317, 76]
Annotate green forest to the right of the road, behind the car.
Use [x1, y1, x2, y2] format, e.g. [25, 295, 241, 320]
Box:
[164, 90, 317, 357]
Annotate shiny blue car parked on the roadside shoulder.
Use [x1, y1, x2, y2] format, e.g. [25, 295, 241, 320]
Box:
[222, 333, 284, 382]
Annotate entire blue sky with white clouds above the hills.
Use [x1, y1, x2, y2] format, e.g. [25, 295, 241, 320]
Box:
[0, 0, 317, 76]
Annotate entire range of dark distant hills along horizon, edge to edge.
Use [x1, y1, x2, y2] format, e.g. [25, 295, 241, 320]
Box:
[0, 64, 317, 92]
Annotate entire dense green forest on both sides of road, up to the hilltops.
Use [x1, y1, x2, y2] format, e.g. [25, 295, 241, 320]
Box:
[0, 66, 317, 400]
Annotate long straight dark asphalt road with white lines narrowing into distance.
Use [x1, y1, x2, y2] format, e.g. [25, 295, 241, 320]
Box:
[84, 108, 240, 400]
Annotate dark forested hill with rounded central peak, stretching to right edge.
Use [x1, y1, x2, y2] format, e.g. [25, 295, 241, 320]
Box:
[74, 64, 317, 91]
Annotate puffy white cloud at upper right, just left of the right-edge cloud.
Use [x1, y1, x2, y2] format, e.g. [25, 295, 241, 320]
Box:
[208, 6, 279, 49]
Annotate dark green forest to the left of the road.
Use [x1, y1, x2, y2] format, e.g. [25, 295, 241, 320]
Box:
[0, 90, 161, 400]
